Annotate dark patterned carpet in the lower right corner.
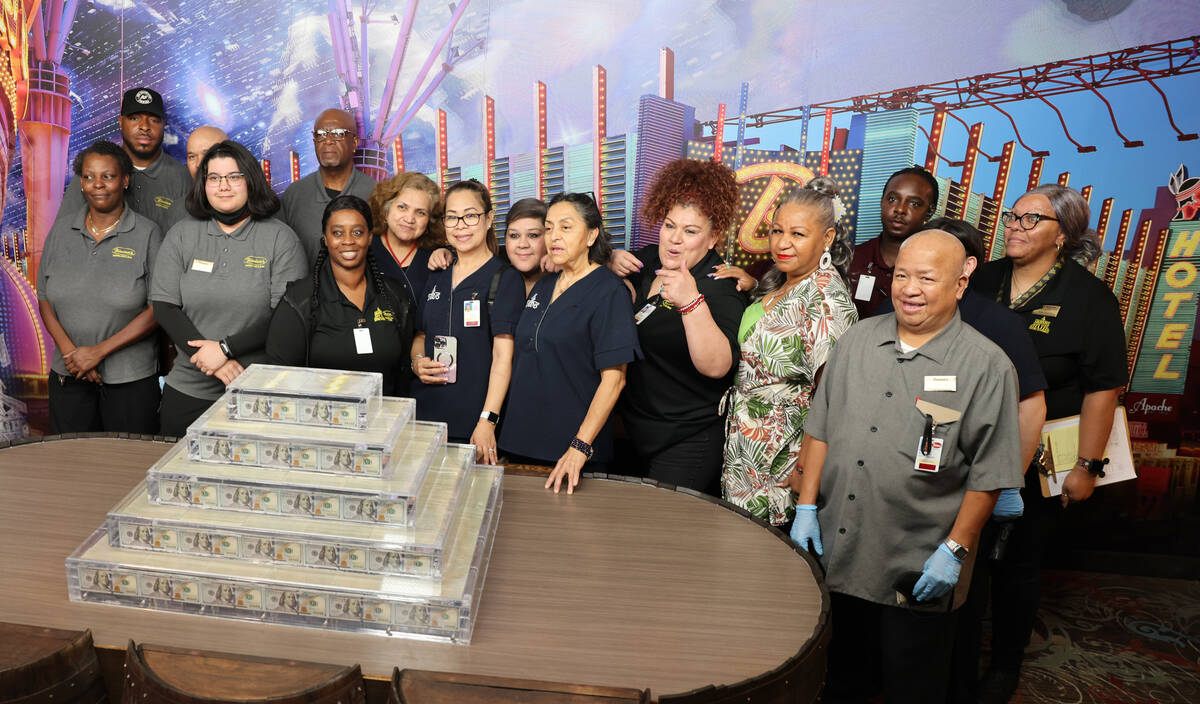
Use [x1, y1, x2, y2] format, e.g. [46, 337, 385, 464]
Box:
[1003, 572, 1200, 704]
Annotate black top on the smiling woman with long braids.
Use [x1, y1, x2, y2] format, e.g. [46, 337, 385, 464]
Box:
[266, 259, 413, 396]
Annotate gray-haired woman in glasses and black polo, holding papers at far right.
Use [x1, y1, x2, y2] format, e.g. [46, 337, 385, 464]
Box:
[971, 183, 1127, 702]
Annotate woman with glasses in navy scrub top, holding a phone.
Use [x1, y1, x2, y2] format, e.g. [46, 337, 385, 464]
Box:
[412, 179, 524, 464]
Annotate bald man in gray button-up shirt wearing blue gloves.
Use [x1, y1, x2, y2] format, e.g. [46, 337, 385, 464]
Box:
[792, 230, 1022, 703]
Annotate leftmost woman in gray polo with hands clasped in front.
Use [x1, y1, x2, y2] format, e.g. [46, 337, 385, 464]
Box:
[37, 142, 162, 433]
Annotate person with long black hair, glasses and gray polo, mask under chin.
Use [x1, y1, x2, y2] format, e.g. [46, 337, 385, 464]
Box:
[150, 140, 307, 437]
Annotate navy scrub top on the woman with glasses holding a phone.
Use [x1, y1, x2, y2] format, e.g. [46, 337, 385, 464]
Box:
[412, 254, 524, 440]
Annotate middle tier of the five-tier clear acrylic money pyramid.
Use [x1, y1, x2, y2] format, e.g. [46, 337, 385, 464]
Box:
[146, 421, 446, 525]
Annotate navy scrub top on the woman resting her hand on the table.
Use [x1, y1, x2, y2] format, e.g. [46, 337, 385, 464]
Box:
[499, 266, 642, 464]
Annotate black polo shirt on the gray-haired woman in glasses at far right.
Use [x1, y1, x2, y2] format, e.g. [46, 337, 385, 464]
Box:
[970, 258, 1128, 420]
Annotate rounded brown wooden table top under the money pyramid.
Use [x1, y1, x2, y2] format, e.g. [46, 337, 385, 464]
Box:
[0, 438, 828, 696]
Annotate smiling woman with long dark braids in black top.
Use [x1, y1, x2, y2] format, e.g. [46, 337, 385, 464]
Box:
[266, 195, 413, 396]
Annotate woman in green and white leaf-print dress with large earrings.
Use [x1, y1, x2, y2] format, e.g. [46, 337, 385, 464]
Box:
[721, 177, 858, 525]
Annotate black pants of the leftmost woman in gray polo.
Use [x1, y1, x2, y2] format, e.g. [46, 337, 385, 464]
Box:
[49, 372, 160, 435]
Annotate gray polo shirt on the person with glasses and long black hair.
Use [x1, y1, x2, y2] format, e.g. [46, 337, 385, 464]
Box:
[150, 218, 308, 399]
